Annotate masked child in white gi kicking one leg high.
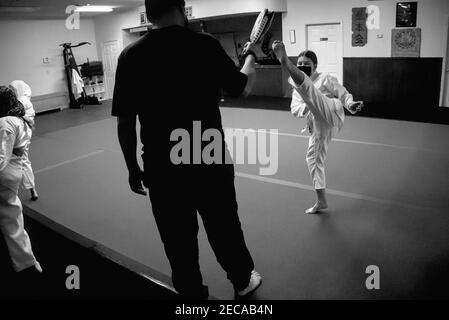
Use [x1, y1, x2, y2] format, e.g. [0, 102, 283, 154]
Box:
[273, 41, 363, 213]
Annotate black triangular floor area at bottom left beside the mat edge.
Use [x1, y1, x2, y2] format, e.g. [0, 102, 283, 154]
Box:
[0, 209, 178, 300]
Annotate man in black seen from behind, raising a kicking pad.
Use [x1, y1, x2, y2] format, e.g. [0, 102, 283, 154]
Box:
[112, 0, 261, 299]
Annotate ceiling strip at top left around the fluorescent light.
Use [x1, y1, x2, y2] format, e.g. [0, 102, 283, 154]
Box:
[0, 0, 145, 19]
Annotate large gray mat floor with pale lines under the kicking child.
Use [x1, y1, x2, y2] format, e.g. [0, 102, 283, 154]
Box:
[22, 102, 449, 299]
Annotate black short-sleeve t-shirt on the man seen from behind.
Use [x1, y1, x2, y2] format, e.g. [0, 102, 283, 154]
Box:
[112, 26, 247, 165]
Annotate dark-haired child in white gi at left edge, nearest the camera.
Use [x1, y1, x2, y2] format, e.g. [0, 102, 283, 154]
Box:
[0, 86, 42, 272]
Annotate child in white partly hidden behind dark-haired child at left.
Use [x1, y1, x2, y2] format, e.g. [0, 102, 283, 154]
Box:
[10, 80, 38, 201]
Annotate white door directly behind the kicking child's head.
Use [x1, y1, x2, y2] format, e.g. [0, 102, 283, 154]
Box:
[306, 23, 343, 83]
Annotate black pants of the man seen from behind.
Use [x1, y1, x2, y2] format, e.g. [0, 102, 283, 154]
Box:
[145, 165, 254, 299]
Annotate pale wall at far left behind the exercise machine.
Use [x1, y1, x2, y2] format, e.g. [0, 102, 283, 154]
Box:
[0, 19, 98, 96]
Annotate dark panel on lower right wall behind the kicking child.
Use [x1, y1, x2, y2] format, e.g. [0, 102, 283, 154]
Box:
[343, 58, 440, 121]
